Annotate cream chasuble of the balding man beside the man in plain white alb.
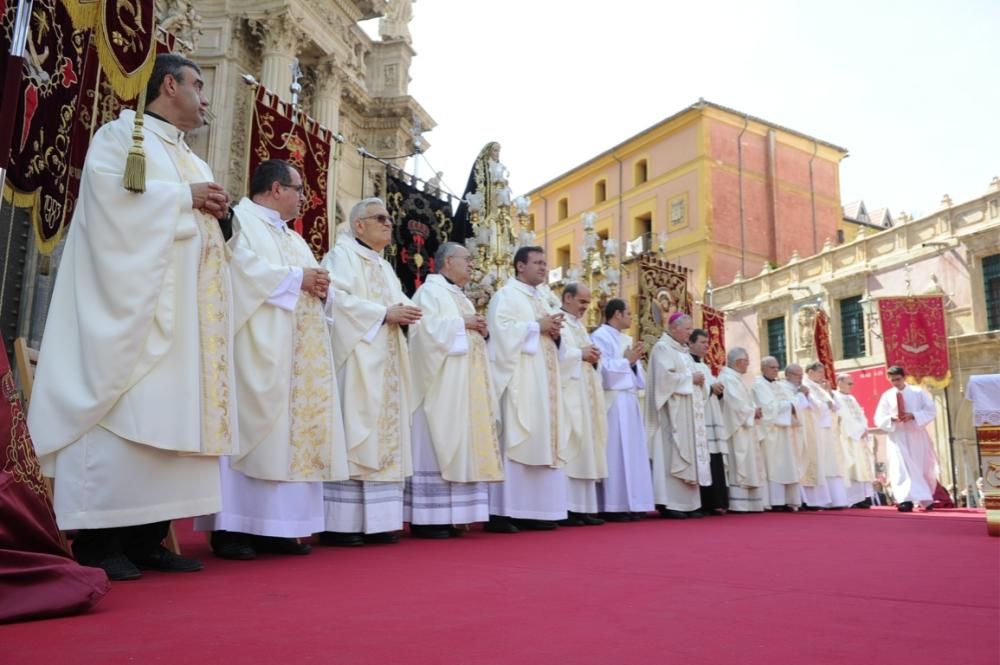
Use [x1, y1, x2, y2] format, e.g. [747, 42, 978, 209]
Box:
[559, 312, 608, 480]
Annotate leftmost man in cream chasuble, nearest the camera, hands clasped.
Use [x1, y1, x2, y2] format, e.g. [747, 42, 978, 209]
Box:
[28, 55, 248, 580]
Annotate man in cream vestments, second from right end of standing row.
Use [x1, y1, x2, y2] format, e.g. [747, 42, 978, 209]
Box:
[802, 361, 851, 508]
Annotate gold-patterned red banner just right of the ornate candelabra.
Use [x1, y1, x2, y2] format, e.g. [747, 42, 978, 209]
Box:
[639, 254, 691, 349]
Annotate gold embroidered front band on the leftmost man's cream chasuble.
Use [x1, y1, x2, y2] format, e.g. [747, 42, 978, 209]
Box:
[170, 142, 233, 455]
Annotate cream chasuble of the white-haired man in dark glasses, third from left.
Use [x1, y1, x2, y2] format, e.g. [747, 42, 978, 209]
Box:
[322, 233, 415, 482]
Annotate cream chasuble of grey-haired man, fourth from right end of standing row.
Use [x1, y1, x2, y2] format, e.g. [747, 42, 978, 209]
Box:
[753, 376, 802, 482]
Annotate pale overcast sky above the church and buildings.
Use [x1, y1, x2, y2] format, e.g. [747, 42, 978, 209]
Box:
[365, 0, 1000, 217]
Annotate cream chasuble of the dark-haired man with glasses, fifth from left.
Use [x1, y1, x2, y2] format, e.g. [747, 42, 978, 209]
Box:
[486, 279, 567, 468]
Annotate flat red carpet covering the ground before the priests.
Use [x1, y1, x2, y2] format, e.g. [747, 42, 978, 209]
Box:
[0, 509, 1000, 665]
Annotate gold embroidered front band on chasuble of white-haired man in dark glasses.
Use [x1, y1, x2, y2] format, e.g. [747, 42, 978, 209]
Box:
[360, 257, 400, 481]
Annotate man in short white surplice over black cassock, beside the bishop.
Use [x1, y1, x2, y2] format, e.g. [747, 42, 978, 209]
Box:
[688, 328, 729, 515]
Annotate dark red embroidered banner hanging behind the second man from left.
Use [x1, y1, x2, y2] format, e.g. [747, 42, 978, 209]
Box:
[247, 85, 333, 261]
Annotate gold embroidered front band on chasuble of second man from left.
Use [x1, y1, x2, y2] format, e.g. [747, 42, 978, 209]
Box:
[268, 224, 336, 480]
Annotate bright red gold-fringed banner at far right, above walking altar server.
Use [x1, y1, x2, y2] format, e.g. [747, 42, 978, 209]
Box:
[878, 295, 951, 388]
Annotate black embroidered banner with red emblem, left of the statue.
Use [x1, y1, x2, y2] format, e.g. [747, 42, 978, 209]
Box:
[385, 167, 452, 296]
